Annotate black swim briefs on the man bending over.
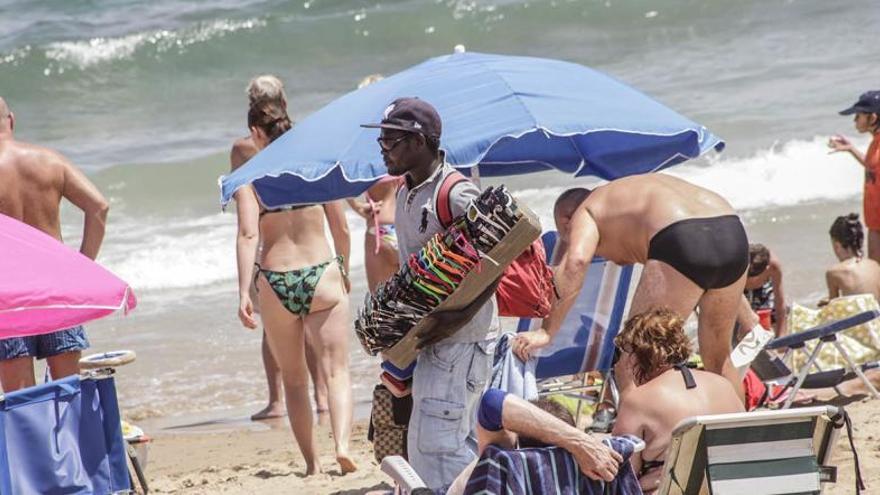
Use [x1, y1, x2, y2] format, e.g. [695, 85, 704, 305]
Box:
[648, 215, 749, 290]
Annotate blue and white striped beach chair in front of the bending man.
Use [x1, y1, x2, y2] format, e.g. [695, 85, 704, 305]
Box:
[517, 231, 640, 414]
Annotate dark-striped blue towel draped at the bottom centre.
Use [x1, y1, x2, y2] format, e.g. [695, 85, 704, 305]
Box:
[464, 437, 642, 495]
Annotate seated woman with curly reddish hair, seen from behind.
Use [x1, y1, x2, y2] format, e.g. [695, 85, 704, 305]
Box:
[613, 308, 744, 493]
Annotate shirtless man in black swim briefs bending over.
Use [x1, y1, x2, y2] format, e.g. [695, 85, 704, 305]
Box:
[513, 174, 749, 400]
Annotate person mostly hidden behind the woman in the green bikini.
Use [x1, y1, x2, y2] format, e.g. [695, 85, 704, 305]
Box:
[229, 75, 328, 421]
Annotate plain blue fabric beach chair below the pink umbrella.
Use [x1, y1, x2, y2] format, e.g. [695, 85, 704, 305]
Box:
[0, 373, 131, 495]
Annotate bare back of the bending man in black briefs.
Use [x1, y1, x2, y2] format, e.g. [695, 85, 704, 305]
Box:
[582, 174, 734, 265]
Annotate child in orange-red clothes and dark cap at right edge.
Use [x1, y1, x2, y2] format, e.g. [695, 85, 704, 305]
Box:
[828, 91, 880, 262]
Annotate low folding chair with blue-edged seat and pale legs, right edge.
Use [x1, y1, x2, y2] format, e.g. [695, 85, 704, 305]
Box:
[752, 310, 880, 409]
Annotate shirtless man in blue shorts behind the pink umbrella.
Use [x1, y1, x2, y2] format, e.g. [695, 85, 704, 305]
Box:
[0, 98, 110, 392]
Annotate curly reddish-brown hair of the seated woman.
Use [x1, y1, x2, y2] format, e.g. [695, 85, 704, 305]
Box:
[614, 308, 691, 384]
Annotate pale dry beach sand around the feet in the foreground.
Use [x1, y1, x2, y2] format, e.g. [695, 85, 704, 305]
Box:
[147, 400, 880, 495]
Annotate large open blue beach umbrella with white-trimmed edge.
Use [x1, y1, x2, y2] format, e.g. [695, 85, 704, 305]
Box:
[221, 52, 724, 208]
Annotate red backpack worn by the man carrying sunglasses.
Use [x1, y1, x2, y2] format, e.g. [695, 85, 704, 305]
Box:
[434, 172, 556, 318]
